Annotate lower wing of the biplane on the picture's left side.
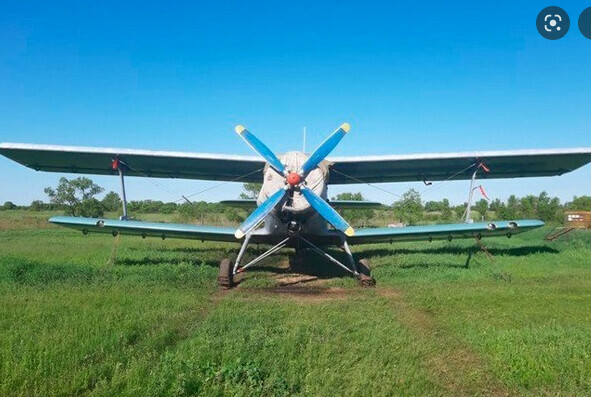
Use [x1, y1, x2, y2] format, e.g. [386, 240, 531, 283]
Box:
[49, 216, 277, 244]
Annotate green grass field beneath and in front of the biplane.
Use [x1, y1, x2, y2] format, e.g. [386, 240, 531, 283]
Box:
[0, 211, 591, 396]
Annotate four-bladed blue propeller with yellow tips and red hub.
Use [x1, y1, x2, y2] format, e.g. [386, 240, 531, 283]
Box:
[234, 123, 355, 239]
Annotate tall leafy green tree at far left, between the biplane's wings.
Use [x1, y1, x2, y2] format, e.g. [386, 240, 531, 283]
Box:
[44, 177, 104, 216]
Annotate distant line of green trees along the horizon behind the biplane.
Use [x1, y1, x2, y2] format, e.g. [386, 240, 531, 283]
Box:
[0, 177, 591, 227]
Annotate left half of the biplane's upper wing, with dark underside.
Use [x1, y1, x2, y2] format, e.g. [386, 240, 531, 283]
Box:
[0, 143, 265, 182]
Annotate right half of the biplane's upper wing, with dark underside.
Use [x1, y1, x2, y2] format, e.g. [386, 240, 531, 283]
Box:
[328, 148, 591, 184]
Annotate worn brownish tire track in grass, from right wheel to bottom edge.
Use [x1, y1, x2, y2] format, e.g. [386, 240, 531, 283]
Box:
[376, 287, 508, 396]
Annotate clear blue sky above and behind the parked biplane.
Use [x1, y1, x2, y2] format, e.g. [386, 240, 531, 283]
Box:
[0, 1, 591, 204]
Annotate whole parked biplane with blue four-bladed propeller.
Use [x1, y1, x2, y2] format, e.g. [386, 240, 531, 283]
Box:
[0, 123, 591, 288]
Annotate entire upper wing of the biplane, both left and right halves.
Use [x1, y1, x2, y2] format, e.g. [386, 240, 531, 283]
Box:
[0, 143, 591, 184]
